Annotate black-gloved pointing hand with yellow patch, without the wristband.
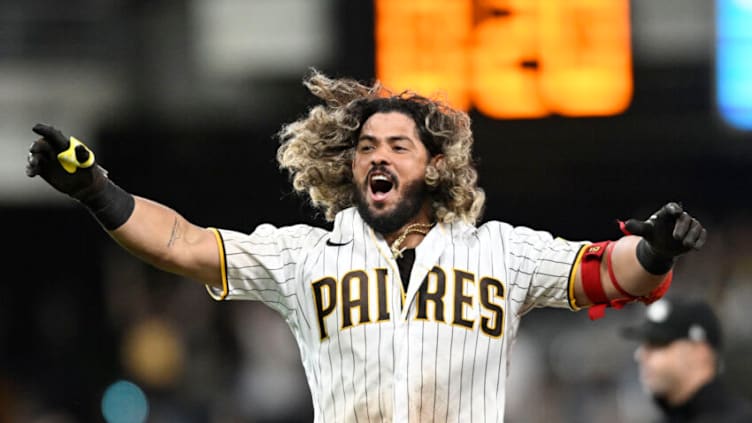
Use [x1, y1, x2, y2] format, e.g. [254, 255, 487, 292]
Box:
[26, 123, 107, 200]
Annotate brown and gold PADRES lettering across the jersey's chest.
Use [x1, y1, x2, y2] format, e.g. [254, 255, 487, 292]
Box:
[308, 261, 508, 341]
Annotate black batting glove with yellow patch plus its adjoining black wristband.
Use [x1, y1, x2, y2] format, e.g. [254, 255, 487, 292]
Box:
[26, 123, 134, 230]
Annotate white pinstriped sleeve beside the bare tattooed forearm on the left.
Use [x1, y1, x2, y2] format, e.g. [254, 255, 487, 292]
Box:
[207, 224, 322, 315]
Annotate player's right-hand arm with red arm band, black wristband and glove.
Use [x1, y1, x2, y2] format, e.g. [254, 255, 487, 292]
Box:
[574, 203, 707, 316]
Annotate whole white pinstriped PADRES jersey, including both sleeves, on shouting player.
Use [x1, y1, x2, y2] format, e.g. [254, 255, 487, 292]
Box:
[209, 208, 587, 423]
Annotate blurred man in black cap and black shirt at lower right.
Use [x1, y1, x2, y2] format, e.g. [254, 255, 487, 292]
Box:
[622, 297, 752, 423]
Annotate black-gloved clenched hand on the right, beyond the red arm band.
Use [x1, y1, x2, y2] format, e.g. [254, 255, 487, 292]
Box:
[623, 202, 708, 274]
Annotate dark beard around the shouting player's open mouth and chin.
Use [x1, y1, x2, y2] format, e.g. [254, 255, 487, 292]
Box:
[353, 180, 428, 235]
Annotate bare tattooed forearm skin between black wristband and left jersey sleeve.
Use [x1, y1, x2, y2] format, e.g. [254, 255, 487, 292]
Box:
[108, 196, 220, 285]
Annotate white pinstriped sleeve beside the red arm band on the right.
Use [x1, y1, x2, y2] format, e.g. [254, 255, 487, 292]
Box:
[506, 227, 589, 313]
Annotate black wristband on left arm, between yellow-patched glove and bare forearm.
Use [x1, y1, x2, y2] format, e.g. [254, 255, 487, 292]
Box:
[80, 179, 136, 231]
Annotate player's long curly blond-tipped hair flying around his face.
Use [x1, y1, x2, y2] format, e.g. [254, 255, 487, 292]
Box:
[277, 69, 485, 224]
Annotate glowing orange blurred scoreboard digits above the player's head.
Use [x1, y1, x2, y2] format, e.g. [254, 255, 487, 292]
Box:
[374, 0, 633, 119]
